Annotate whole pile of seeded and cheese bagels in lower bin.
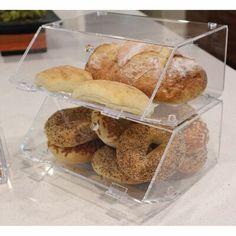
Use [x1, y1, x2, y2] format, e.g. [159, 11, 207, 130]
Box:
[45, 107, 208, 184]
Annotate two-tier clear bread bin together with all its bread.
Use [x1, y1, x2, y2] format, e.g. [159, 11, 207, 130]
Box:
[11, 12, 228, 202]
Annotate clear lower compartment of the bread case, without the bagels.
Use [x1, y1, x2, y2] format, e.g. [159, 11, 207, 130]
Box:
[18, 97, 222, 204]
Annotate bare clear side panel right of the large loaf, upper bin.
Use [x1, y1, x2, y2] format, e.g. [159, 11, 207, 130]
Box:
[177, 23, 228, 97]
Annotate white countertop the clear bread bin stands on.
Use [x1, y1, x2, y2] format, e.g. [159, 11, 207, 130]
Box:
[0, 12, 236, 225]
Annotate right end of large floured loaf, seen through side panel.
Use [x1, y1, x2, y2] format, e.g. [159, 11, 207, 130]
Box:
[155, 55, 207, 103]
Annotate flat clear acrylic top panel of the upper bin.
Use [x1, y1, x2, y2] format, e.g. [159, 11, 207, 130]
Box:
[44, 11, 225, 47]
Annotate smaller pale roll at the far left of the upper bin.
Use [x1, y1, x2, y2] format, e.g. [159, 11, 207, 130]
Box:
[35, 65, 93, 93]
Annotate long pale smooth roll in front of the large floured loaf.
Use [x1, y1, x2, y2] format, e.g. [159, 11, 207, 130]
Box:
[72, 80, 154, 115]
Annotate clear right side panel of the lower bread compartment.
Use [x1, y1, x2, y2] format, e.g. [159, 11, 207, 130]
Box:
[144, 98, 223, 202]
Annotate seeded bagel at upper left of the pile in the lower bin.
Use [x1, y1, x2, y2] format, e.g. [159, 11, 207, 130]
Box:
[44, 107, 97, 147]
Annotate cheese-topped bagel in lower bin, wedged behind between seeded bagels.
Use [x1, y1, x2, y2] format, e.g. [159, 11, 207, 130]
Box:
[92, 111, 131, 147]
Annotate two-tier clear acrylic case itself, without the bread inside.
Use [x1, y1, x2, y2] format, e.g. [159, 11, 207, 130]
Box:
[11, 12, 228, 203]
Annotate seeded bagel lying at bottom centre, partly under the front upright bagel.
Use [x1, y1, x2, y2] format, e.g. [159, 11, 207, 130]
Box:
[91, 146, 142, 184]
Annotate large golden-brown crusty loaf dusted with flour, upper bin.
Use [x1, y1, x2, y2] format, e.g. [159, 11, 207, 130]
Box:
[85, 42, 207, 104]
